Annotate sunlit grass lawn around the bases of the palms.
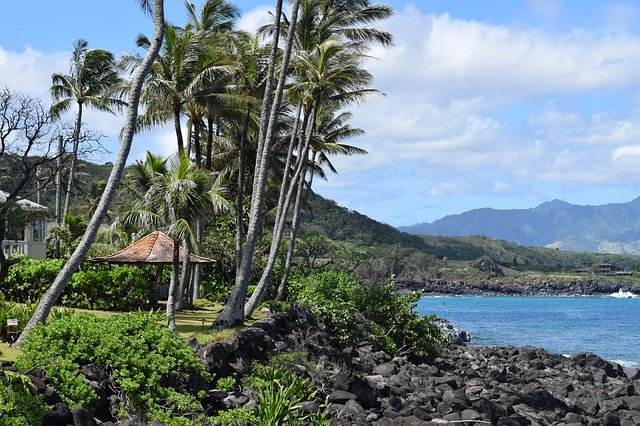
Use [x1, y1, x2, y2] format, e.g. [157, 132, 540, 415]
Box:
[0, 304, 265, 361]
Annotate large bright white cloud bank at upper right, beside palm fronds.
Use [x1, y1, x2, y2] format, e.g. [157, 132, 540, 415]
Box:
[370, 8, 640, 99]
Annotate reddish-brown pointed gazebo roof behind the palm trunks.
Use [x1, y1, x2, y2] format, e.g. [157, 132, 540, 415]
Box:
[91, 231, 215, 264]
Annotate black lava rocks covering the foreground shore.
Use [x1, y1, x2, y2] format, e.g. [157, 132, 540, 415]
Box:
[20, 309, 640, 426]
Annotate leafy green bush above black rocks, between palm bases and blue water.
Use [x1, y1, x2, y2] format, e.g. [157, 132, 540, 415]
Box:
[290, 271, 444, 358]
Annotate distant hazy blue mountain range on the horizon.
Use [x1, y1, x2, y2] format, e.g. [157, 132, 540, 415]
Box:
[398, 197, 640, 254]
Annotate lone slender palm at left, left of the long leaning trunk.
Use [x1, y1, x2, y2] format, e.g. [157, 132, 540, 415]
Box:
[51, 39, 126, 217]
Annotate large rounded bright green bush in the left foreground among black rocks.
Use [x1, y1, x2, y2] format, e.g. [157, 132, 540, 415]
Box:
[16, 313, 209, 420]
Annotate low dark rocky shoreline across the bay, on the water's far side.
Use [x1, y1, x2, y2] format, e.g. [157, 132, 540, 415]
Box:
[398, 279, 640, 296]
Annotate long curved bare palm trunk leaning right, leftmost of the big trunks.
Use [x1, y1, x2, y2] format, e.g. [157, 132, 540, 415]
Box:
[16, 0, 164, 346]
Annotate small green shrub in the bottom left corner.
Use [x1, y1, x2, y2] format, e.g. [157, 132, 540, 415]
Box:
[0, 370, 48, 426]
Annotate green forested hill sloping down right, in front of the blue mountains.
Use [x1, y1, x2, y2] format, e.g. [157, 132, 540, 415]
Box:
[303, 195, 640, 275]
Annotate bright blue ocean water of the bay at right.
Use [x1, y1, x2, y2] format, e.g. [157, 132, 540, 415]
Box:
[417, 296, 640, 367]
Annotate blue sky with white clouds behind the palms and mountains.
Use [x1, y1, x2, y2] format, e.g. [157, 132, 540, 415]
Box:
[0, 0, 640, 226]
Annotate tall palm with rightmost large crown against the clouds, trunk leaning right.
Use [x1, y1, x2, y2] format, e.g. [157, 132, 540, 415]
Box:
[244, 0, 392, 316]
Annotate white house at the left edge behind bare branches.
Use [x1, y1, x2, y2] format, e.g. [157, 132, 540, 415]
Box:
[0, 190, 49, 259]
